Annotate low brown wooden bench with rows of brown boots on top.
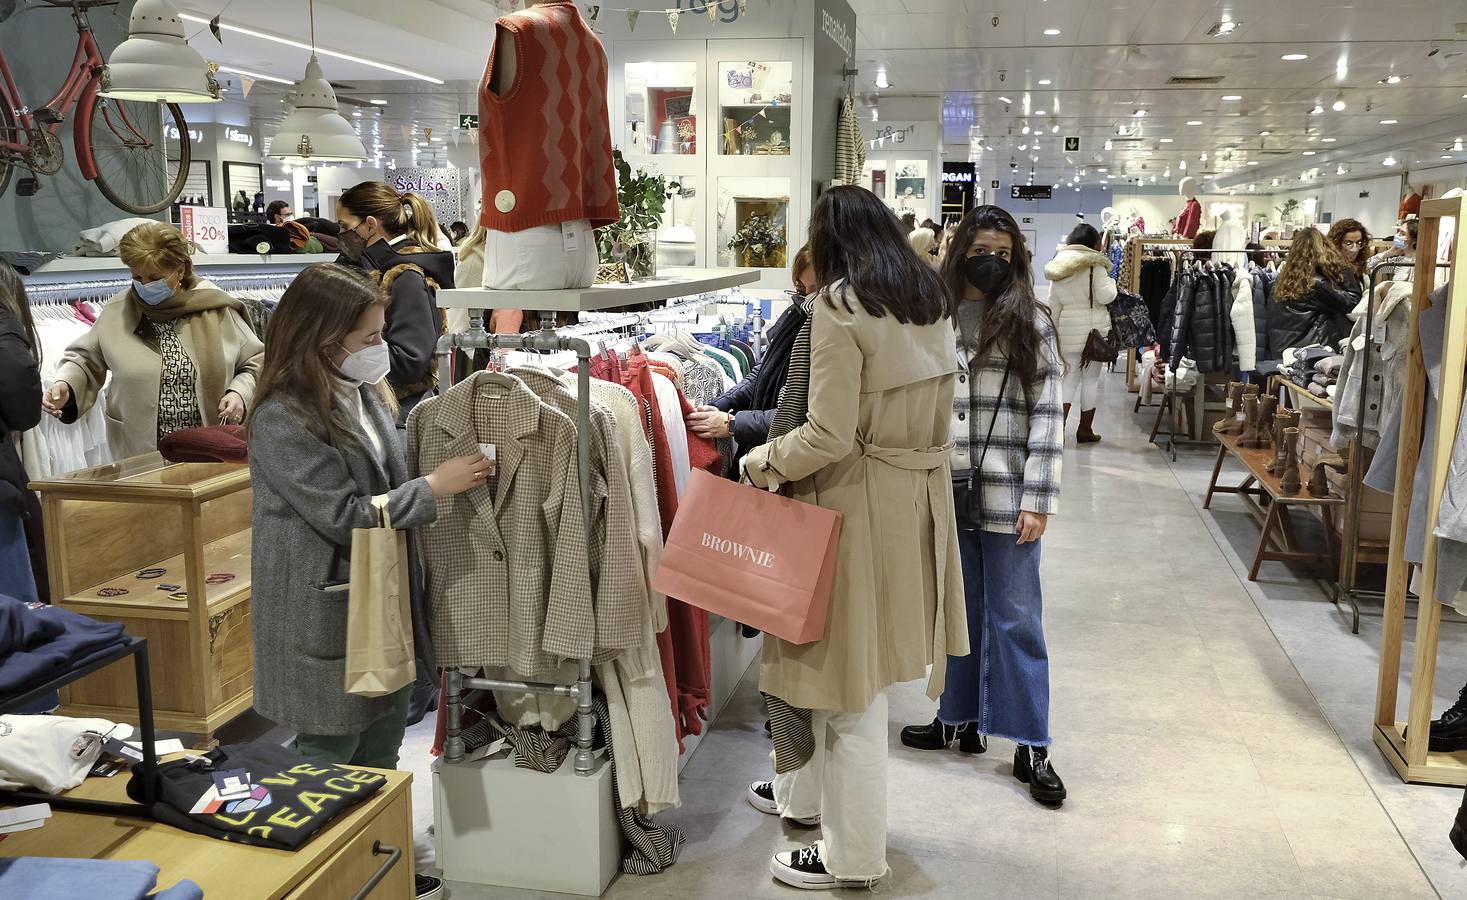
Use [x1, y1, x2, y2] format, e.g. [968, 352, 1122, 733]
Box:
[1201, 435, 1345, 581]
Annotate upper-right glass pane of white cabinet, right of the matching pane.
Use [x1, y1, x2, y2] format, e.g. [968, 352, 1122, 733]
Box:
[717, 60, 795, 156]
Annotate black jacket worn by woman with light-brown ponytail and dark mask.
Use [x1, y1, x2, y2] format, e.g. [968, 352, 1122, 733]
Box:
[361, 236, 453, 423]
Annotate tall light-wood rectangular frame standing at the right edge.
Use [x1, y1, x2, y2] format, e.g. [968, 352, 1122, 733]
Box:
[1372, 197, 1467, 785]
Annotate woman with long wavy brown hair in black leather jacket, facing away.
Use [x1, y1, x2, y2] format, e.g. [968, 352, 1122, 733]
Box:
[1269, 228, 1361, 354]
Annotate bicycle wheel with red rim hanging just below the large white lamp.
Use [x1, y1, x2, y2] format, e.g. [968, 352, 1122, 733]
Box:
[89, 97, 191, 216]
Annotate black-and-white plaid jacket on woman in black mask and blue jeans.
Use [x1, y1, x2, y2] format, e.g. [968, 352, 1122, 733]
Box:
[952, 316, 1065, 533]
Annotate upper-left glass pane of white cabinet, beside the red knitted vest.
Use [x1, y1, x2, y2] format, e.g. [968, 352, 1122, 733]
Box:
[622, 62, 698, 156]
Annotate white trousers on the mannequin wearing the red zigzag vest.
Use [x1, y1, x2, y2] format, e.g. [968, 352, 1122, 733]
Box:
[481, 219, 599, 287]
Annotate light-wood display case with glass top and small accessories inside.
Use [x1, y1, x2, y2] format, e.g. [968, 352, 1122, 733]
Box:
[31, 454, 254, 743]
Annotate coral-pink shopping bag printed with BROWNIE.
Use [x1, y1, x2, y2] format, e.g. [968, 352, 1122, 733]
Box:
[651, 470, 841, 643]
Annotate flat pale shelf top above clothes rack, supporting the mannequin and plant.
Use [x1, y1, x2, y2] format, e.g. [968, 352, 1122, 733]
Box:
[439, 262, 760, 313]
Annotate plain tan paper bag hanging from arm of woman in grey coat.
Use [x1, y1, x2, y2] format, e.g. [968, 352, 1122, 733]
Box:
[346, 496, 417, 697]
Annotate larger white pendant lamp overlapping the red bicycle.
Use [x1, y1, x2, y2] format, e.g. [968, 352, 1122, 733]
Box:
[98, 0, 220, 103]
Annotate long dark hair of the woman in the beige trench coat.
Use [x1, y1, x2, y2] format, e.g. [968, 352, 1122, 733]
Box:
[810, 185, 951, 324]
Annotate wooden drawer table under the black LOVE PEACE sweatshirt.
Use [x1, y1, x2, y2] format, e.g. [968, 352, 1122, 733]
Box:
[0, 755, 414, 900]
